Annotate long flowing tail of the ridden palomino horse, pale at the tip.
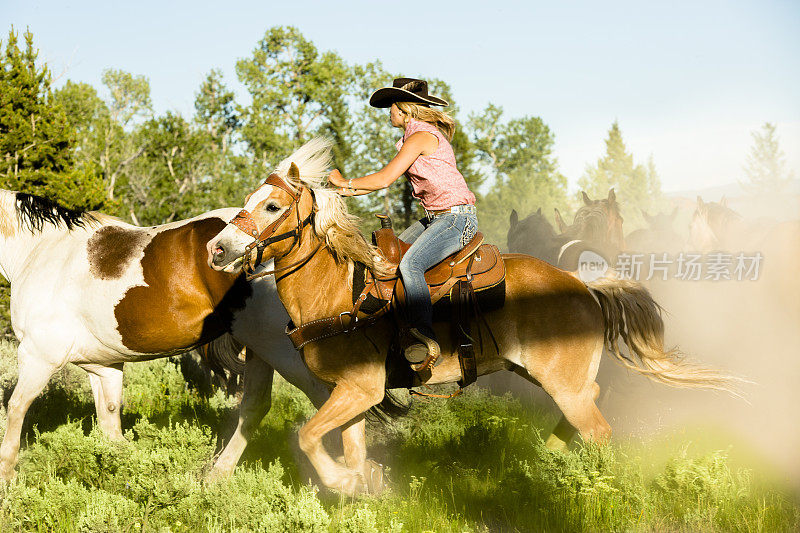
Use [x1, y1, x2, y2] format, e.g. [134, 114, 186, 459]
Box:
[586, 277, 745, 396]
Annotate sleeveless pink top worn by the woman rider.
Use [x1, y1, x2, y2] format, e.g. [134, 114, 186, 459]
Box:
[397, 118, 475, 211]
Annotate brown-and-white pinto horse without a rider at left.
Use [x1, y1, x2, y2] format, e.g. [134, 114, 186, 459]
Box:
[0, 190, 328, 480]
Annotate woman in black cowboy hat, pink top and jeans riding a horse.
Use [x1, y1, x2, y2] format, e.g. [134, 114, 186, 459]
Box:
[328, 78, 478, 371]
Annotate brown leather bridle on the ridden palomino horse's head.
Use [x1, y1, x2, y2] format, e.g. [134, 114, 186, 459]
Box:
[228, 174, 322, 281]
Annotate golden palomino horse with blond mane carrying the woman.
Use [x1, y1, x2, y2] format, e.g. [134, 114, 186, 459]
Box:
[208, 139, 727, 494]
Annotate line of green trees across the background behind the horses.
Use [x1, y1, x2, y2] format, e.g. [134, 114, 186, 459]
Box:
[0, 26, 786, 247]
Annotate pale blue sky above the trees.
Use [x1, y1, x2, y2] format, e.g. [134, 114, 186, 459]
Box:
[0, 0, 800, 195]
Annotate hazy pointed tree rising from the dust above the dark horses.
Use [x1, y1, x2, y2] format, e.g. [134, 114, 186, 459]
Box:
[578, 121, 664, 228]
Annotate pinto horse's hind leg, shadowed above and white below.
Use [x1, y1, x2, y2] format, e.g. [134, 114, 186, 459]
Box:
[206, 348, 275, 481]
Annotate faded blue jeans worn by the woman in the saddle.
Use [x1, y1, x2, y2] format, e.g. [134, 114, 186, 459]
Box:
[400, 213, 478, 340]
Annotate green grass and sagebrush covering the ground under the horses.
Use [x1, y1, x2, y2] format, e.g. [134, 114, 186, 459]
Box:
[0, 343, 800, 532]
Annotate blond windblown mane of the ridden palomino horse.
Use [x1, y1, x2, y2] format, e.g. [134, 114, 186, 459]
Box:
[275, 137, 389, 274]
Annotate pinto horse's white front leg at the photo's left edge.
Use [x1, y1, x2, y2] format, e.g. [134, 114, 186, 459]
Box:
[0, 343, 57, 481]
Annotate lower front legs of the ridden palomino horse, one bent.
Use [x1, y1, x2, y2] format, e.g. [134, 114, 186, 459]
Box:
[299, 382, 384, 496]
